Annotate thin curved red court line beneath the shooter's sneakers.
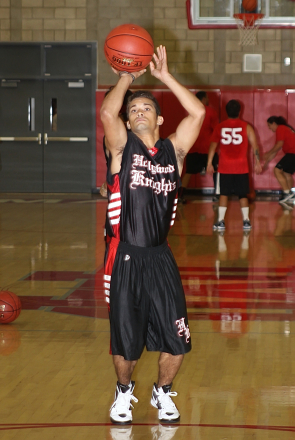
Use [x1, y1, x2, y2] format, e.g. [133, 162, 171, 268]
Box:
[0, 422, 295, 432]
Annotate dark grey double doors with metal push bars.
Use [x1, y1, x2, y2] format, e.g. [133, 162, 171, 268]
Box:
[0, 43, 96, 193]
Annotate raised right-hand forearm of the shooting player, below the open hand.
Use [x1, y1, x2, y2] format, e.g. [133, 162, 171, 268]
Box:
[162, 73, 205, 118]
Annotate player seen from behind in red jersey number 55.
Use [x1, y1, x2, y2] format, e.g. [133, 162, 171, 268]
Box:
[207, 99, 261, 231]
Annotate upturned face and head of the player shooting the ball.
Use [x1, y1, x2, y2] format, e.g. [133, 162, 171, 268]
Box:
[127, 98, 160, 132]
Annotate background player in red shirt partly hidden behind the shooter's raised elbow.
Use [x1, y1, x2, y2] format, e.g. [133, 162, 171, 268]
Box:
[178, 90, 219, 203]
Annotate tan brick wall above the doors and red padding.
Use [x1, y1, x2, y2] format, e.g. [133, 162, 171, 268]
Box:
[0, 0, 295, 86]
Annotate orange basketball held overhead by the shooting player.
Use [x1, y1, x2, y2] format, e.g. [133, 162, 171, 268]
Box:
[104, 24, 154, 72]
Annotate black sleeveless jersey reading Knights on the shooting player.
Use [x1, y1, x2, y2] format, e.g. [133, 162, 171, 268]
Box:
[106, 132, 179, 247]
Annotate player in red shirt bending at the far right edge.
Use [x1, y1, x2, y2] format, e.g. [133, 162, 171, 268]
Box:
[263, 116, 295, 203]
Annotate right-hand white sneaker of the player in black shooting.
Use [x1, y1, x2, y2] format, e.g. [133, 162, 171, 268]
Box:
[151, 384, 180, 423]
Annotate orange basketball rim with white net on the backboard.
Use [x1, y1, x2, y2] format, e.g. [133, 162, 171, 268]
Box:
[234, 12, 264, 46]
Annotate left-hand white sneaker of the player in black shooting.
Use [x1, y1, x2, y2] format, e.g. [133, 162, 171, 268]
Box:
[110, 381, 138, 424]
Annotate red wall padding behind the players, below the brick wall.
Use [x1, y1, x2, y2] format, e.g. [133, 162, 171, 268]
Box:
[96, 88, 295, 190]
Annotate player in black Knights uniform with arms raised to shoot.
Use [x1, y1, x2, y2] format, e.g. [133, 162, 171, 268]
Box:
[101, 46, 205, 424]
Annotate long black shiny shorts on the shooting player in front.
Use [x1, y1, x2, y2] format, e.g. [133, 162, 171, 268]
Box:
[109, 242, 191, 361]
